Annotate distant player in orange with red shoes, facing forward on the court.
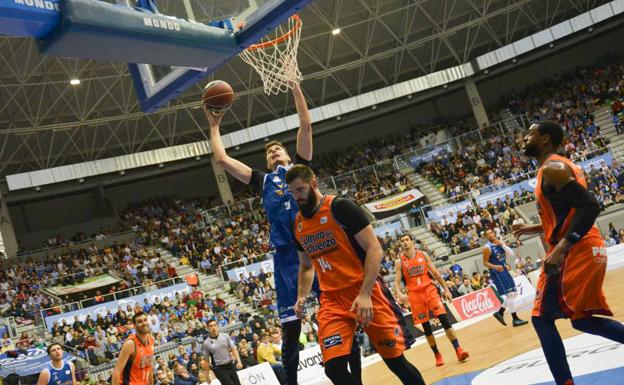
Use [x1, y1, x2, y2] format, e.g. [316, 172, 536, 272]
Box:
[394, 234, 469, 366]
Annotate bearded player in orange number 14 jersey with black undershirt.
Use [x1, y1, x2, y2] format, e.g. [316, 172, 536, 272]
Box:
[286, 165, 425, 385]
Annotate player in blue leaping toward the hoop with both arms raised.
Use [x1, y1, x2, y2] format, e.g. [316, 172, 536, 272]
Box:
[204, 84, 361, 385]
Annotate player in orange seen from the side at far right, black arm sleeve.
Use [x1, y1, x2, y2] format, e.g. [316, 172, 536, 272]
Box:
[513, 121, 624, 385]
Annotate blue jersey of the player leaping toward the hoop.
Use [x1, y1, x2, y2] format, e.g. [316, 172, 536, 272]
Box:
[262, 165, 299, 249]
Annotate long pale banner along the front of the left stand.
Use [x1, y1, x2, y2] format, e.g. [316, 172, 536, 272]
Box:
[45, 283, 191, 330]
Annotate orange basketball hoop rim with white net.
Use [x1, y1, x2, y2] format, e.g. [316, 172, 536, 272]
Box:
[240, 14, 303, 95]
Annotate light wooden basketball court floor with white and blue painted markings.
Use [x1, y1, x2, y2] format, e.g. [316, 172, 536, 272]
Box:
[362, 269, 624, 385]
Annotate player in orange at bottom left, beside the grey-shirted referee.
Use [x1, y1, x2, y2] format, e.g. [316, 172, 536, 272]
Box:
[111, 312, 154, 385]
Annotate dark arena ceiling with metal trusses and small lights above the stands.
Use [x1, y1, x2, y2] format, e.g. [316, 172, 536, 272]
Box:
[0, 0, 608, 175]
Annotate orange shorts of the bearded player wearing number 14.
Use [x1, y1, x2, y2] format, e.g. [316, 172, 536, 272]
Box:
[317, 282, 408, 362]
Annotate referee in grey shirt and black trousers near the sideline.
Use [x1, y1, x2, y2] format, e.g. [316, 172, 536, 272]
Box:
[202, 320, 243, 385]
